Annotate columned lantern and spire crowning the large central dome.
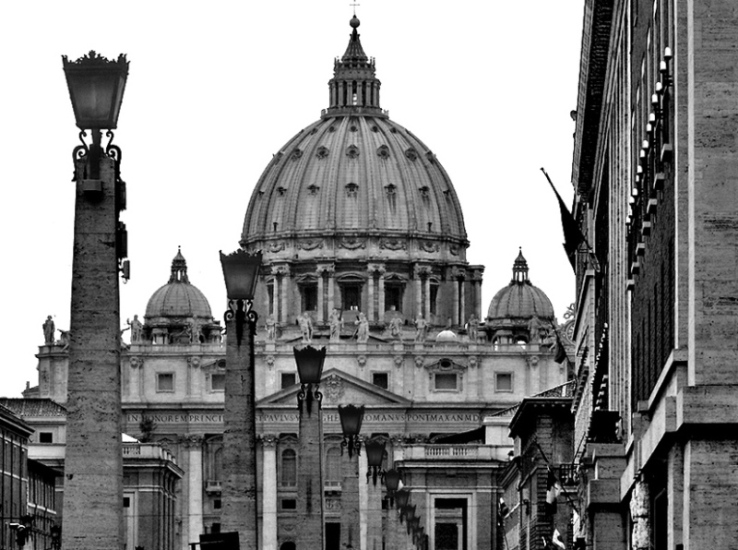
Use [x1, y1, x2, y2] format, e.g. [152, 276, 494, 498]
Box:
[324, 13, 382, 116]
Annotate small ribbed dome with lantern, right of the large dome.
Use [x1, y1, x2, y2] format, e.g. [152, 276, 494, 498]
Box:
[487, 251, 554, 327]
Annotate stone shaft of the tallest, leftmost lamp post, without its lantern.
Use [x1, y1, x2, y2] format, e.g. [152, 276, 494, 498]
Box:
[62, 154, 124, 550]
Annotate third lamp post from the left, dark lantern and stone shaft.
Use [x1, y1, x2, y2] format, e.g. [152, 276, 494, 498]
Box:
[294, 346, 325, 549]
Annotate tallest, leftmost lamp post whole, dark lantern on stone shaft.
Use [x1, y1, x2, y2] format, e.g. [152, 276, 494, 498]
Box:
[62, 52, 128, 550]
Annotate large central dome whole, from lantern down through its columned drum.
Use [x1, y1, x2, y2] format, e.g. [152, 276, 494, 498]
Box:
[241, 17, 483, 330]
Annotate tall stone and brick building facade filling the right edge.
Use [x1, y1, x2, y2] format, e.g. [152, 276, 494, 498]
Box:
[573, 0, 738, 550]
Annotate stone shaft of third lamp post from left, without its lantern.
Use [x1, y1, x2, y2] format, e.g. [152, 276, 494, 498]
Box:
[296, 394, 325, 549]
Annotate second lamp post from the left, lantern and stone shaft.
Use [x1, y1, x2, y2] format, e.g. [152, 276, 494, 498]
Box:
[220, 250, 261, 550]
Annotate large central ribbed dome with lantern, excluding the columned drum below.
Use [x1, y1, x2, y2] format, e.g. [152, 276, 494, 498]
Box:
[241, 15, 468, 261]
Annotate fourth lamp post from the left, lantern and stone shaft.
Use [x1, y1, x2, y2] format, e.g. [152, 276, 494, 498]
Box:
[338, 405, 364, 548]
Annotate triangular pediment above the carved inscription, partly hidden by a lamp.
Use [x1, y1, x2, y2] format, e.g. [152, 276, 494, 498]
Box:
[256, 369, 412, 407]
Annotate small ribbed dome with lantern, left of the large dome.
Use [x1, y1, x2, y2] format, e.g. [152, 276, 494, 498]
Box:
[145, 251, 212, 322]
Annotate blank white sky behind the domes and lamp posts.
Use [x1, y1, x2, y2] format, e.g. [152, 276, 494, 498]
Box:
[0, 0, 584, 397]
